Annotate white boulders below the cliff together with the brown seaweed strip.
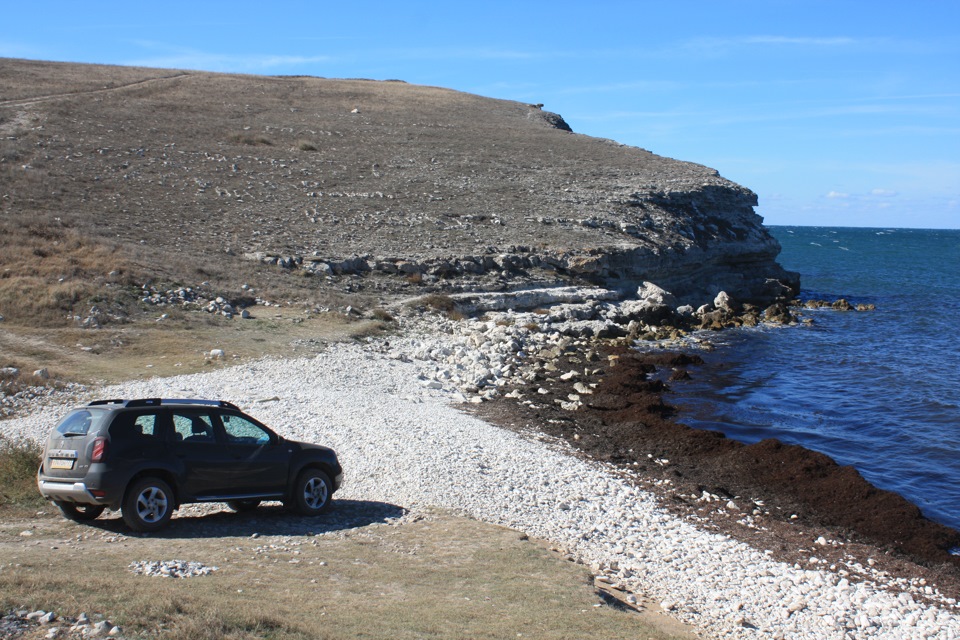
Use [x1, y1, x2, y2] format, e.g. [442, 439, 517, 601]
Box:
[368, 283, 960, 598]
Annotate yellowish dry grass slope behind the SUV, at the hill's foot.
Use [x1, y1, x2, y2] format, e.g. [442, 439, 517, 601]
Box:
[0, 208, 388, 384]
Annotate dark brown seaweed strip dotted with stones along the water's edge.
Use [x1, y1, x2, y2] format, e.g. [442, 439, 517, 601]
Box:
[476, 347, 960, 598]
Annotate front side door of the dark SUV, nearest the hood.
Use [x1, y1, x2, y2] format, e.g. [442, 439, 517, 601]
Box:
[220, 411, 290, 498]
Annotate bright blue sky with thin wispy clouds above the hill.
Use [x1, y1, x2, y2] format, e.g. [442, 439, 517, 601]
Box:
[0, 0, 960, 228]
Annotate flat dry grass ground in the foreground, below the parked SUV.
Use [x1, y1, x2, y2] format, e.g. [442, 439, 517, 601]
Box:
[0, 505, 690, 640]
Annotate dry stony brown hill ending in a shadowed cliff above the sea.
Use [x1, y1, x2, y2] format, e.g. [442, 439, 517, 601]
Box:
[0, 60, 798, 304]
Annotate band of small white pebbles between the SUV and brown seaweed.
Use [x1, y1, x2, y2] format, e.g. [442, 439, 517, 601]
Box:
[0, 345, 960, 640]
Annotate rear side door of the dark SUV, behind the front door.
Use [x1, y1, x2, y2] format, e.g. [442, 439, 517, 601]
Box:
[170, 407, 233, 500]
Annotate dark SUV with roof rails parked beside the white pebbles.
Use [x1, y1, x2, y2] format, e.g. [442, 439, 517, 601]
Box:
[37, 398, 343, 531]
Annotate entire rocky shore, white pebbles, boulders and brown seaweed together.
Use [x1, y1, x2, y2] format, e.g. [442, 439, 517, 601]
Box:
[0, 290, 960, 639]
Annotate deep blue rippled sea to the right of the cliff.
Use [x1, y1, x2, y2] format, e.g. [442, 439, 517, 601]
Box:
[670, 226, 960, 529]
